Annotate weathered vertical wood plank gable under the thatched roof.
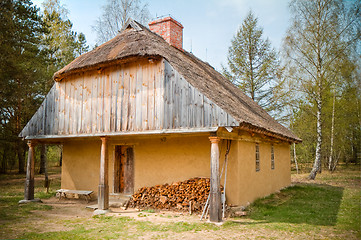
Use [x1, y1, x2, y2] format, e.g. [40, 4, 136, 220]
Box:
[20, 60, 238, 137]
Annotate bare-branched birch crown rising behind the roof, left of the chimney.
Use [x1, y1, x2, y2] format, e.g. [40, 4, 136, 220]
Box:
[92, 0, 150, 45]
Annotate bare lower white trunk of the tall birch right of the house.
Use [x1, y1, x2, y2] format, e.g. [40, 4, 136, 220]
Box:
[309, 93, 322, 180]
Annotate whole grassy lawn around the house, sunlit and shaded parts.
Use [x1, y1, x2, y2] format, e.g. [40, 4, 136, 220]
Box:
[0, 167, 361, 239]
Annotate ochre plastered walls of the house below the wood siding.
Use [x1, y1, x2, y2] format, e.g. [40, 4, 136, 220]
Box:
[61, 134, 291, 205]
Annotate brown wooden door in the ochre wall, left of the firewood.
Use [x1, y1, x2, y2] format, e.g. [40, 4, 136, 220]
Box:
[114, 145, 134, 194]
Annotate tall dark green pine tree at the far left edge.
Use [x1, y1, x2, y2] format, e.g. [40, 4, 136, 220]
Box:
[0, 0, 45, 173]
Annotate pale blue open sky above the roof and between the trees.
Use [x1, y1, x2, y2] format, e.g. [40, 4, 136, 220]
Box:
[33, 0, 290, 70]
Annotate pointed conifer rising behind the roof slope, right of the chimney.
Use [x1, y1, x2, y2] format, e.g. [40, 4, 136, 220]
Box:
[223, 11, 280, 118]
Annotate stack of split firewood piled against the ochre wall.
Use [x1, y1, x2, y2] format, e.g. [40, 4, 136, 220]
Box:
[129, 178, 215, 212]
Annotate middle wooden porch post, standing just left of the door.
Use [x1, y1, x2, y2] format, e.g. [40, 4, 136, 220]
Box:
[98, 137, 109, 210]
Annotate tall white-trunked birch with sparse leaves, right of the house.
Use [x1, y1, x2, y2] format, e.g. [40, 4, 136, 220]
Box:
[284, 0, 361, 179]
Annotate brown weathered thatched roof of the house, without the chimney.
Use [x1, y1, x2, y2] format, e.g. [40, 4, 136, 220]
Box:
[54, 21, 301, 142]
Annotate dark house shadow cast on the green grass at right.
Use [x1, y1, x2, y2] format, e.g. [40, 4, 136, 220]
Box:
[245, 184, 344, 226]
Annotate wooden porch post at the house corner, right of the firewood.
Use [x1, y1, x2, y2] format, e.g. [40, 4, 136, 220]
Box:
[209, 137, 222, 222]
